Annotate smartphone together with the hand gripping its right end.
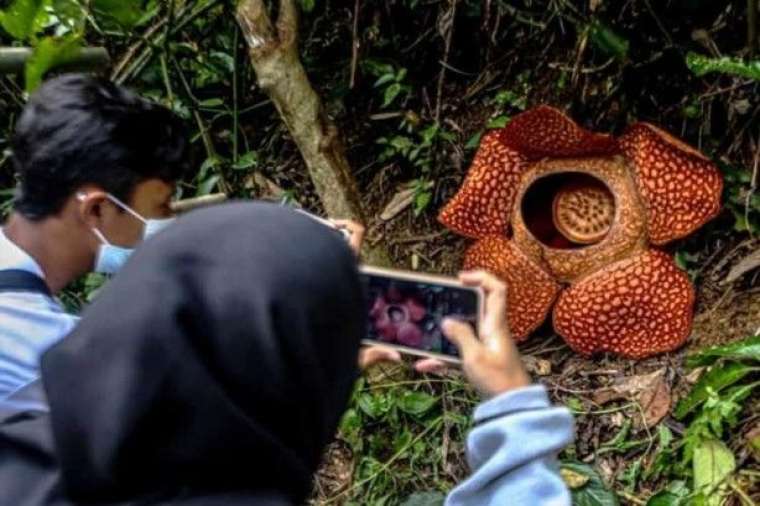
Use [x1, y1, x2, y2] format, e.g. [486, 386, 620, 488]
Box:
[362, 267, 530, 398]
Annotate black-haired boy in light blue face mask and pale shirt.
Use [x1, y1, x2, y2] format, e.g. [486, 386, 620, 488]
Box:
[0, 74, 189, 401]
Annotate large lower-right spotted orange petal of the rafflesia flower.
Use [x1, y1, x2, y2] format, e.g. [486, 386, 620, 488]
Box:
[554, 250, 694, 359]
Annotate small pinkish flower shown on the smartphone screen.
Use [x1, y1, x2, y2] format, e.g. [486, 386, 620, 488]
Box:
[370, 289, 426, 348]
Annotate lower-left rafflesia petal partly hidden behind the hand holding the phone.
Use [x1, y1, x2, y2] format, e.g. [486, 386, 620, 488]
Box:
[464, 236, 560, 341]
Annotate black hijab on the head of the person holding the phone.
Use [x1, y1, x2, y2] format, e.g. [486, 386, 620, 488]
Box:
[0, 204, 363, 505]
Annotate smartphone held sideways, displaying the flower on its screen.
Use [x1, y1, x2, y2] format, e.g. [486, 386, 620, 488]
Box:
[360, 266, 483, 363]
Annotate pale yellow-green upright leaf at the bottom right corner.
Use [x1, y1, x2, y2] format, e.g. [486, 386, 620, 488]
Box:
[694, 439, 736, 506]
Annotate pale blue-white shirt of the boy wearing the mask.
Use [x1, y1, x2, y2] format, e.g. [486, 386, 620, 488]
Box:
[0, 230, 79, 401]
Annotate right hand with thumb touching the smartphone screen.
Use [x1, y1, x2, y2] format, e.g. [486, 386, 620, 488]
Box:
[442, 271, 530, 398]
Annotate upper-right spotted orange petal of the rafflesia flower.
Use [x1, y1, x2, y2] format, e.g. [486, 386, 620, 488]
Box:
[620, 123, 723, 245]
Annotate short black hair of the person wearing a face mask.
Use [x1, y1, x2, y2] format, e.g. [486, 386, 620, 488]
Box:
[11, 74, 189, 220]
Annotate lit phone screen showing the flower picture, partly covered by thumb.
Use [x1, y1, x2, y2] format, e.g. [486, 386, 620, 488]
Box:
[362, 274, 478, 356]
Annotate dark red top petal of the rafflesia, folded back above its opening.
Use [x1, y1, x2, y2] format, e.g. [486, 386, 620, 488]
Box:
[500, 105, 619, 159]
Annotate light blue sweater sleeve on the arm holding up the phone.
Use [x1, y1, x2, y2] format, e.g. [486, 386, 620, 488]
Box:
[446, 385, 574, 506]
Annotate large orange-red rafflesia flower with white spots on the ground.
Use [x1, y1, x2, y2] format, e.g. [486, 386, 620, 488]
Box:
[439, 106, 723, 358]
